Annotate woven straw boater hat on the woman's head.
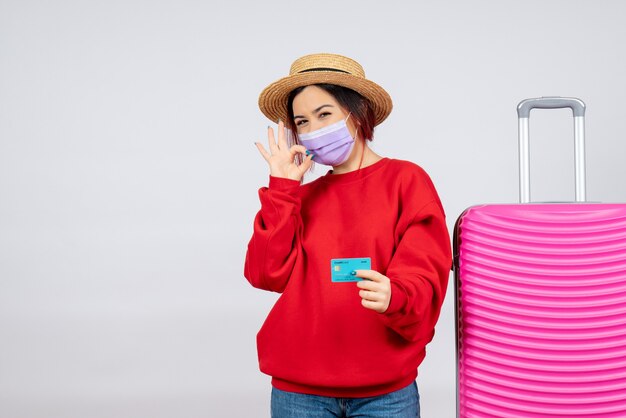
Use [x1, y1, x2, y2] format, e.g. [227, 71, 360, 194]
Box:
[259, 54, 393, 125]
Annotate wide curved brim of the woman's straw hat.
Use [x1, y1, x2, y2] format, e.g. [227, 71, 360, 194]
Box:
[259, 71, 393, 125]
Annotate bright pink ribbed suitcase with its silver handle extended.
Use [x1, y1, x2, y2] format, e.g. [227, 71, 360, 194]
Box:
[454, 97, 626, 418]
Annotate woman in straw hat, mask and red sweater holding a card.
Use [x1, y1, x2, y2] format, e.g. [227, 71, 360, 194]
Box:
[245, 54, 451, 418]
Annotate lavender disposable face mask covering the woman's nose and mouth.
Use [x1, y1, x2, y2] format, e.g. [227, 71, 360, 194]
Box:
[298, 115, 354, 166]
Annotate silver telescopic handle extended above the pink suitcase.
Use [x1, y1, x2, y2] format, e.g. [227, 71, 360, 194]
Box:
[517, 97, 587, 203]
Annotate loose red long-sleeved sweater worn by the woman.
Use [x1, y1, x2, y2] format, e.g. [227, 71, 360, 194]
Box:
[244, 158, 452, 397]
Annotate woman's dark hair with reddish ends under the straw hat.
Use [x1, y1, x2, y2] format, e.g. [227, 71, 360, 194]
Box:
[285, 84, 376, 155]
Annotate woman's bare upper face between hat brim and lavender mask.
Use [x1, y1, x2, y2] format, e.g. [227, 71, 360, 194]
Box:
[293, 86, 355, 137]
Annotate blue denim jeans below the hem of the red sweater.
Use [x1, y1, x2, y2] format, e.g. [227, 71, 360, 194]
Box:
[271, 382, 420, 418]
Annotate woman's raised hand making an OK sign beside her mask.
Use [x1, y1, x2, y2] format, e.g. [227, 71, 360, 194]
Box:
[254, 121, 313, 181]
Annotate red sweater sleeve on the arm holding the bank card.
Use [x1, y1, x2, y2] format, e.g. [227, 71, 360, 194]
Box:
[382, 197, 452, 342]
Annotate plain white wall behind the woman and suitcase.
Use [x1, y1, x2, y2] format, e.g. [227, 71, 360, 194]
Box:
[0, 0, 626, 418]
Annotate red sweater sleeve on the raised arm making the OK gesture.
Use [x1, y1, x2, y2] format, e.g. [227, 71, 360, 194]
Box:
[244, 176, 302, 292]
